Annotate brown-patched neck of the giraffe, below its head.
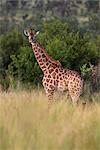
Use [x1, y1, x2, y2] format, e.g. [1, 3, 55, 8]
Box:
[32, 43, 61, 72]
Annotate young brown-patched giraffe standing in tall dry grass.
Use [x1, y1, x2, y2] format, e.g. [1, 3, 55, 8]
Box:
[24, 29, 83, 107]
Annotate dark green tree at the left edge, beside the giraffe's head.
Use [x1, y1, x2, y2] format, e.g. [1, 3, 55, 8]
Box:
[0, 30, 27, 88]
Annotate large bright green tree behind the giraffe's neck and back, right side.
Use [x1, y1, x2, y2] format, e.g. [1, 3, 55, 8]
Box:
[39, 20, 97, 71]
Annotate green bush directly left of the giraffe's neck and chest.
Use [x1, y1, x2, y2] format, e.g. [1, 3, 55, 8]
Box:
[7, 46, 41, 84]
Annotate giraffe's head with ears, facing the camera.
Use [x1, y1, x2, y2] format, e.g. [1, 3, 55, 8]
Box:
[24, 29, 39, 43]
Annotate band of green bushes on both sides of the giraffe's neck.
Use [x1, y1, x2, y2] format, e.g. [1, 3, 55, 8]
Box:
[0, 19, 99, 87]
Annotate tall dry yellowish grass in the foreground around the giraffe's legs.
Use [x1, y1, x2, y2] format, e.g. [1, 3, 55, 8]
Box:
[0, 91, 100, 150]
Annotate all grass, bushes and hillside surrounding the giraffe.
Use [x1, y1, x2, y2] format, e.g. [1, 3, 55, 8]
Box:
[0, 0, 100, 150]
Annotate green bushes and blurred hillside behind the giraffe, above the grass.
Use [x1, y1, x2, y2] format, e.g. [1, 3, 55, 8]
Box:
[0, 0, 100, 89]
